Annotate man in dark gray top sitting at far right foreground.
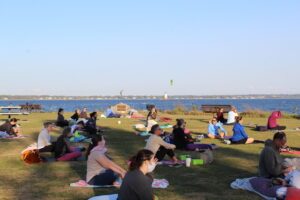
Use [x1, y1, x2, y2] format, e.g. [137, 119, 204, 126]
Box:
[259, 132, 287, 178]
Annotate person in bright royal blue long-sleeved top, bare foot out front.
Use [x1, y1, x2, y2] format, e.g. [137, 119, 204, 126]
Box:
[230, 116, 254, 144]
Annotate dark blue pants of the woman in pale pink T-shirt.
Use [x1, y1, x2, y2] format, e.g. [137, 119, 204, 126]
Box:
[88, 170, 119, 185]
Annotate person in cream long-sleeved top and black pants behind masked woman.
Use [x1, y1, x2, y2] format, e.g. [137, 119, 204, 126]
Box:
[145, 124, 178, 164]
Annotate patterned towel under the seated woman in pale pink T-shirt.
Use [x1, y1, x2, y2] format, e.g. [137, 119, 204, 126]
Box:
[70, 179, 170, 189]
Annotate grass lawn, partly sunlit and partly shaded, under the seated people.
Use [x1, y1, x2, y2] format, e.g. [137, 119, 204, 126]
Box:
[0, 113, 300, 200]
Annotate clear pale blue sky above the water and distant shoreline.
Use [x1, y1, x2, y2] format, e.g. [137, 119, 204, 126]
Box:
[0, 0, 300, 96]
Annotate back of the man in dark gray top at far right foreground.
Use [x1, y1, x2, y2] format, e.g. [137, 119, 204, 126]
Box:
[259, 140, 283, 178]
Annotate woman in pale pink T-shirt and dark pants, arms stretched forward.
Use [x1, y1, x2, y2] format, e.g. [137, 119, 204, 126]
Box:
[86, 135, 126, 185]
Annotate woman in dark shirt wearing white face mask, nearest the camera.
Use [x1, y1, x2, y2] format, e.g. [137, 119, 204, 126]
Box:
[118, 149, 157, 200]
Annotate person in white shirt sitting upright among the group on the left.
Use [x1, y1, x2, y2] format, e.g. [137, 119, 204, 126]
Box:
[37, 122, 54, 152]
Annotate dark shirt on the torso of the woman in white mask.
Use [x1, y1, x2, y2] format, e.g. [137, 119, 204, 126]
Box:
[118, 169, 153, 200]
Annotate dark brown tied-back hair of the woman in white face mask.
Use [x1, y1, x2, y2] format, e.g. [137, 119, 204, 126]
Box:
[129, 149, 154, 171]
